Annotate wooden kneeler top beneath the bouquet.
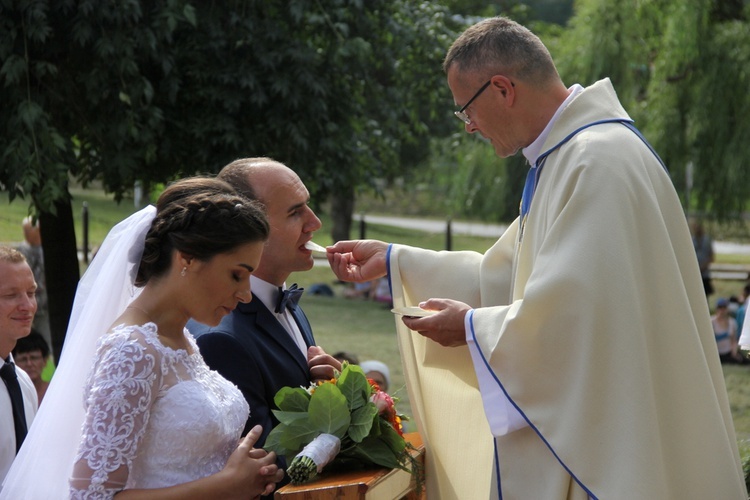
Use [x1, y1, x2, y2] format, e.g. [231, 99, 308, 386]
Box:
[274, 432, 426, 500]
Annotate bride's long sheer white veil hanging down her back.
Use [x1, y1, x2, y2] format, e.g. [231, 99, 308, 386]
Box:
[0, 206, 156, 500]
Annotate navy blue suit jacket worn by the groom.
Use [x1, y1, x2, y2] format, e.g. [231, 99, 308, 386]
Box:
[187, 300, 315, 458]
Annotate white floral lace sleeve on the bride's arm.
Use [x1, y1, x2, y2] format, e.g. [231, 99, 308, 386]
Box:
[70, 332, 162, 499]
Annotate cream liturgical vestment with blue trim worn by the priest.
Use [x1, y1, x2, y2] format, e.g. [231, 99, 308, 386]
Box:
[388, 80, 747, 500]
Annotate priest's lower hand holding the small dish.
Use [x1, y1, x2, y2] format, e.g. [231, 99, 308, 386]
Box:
[402, 299, 471, 347]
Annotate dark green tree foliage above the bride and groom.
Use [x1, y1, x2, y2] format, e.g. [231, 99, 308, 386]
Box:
[0, 0, 453, 352]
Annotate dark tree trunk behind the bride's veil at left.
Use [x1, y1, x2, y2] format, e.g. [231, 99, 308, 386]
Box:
[39, 196, 80, 362]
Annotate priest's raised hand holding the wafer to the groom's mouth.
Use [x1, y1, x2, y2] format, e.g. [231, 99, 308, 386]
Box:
[326, 240, 388, 282]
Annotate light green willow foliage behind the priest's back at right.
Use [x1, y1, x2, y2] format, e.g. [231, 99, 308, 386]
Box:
[558, 0, 750, 219]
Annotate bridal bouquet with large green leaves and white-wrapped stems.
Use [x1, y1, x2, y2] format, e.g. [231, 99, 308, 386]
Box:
[265, 362, 422, 488]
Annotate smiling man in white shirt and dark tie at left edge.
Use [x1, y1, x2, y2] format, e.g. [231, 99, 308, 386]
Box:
[0, 245, 38, 483]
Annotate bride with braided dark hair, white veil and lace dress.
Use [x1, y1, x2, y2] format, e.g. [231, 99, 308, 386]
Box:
[0, 177, 284, 499]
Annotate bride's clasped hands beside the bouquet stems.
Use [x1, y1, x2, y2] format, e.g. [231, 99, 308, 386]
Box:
[222, 425, 284, 498]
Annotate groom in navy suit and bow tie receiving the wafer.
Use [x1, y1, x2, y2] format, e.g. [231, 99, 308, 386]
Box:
[188, 158, 341, 480]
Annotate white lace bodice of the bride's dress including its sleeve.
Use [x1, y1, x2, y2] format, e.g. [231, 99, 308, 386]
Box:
[70, 323, 249, 499]
